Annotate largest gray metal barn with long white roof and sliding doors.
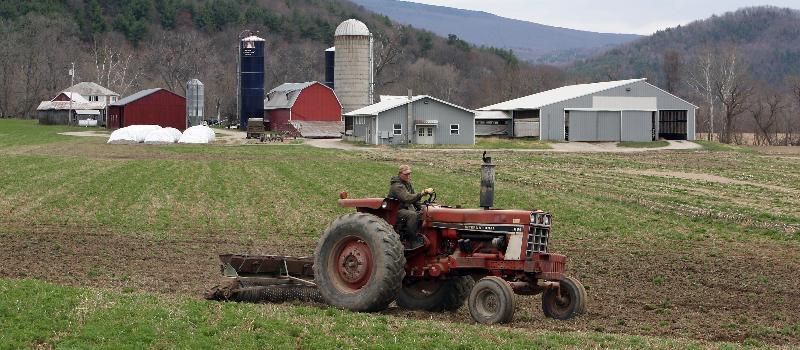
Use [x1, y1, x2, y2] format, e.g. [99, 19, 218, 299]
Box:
[478, 79, 697, 141]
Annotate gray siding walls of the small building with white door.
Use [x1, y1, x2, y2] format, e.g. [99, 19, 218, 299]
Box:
[378, 98, 475, 145]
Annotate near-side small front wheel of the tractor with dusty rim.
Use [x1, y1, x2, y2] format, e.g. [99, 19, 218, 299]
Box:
[469, 276, 516, 324]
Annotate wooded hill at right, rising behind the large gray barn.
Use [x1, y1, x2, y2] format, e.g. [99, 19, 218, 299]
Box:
[569, 7, 800, 89]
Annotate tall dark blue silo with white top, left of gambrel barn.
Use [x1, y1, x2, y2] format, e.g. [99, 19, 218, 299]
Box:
[239, 35, 265, 129]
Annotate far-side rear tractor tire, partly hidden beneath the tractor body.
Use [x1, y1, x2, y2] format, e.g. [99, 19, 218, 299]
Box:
[397, 276, 475, 312]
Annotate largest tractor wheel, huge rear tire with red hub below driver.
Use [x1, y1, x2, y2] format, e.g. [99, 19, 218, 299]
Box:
[314, 213, 406, 312]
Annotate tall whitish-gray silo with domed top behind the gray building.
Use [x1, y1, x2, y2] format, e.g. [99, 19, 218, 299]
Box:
[334, 19, 374, 113]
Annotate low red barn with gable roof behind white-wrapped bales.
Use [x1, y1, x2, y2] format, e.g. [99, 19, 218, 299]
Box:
[107, 88, 186, 131]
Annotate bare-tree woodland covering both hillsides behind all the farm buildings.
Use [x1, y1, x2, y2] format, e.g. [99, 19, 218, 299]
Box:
[0, 0, 800, 144]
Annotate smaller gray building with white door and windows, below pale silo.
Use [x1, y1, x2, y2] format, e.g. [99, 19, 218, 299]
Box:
[345, 95, 475, 145]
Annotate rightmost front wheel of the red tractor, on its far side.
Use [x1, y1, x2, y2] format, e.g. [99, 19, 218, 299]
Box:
[542, 277, 586, 320]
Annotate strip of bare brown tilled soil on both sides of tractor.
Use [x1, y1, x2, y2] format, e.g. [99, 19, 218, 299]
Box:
[0, 223, 800, 345]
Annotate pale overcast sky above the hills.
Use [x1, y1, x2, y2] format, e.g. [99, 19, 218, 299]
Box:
[406, 0, 800, 35]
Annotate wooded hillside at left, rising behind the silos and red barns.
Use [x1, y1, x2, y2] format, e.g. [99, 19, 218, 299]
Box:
[0, 0, 563, 117]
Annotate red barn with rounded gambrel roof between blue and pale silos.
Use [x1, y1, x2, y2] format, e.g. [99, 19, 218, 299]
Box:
[264, 81, 344, 137]
